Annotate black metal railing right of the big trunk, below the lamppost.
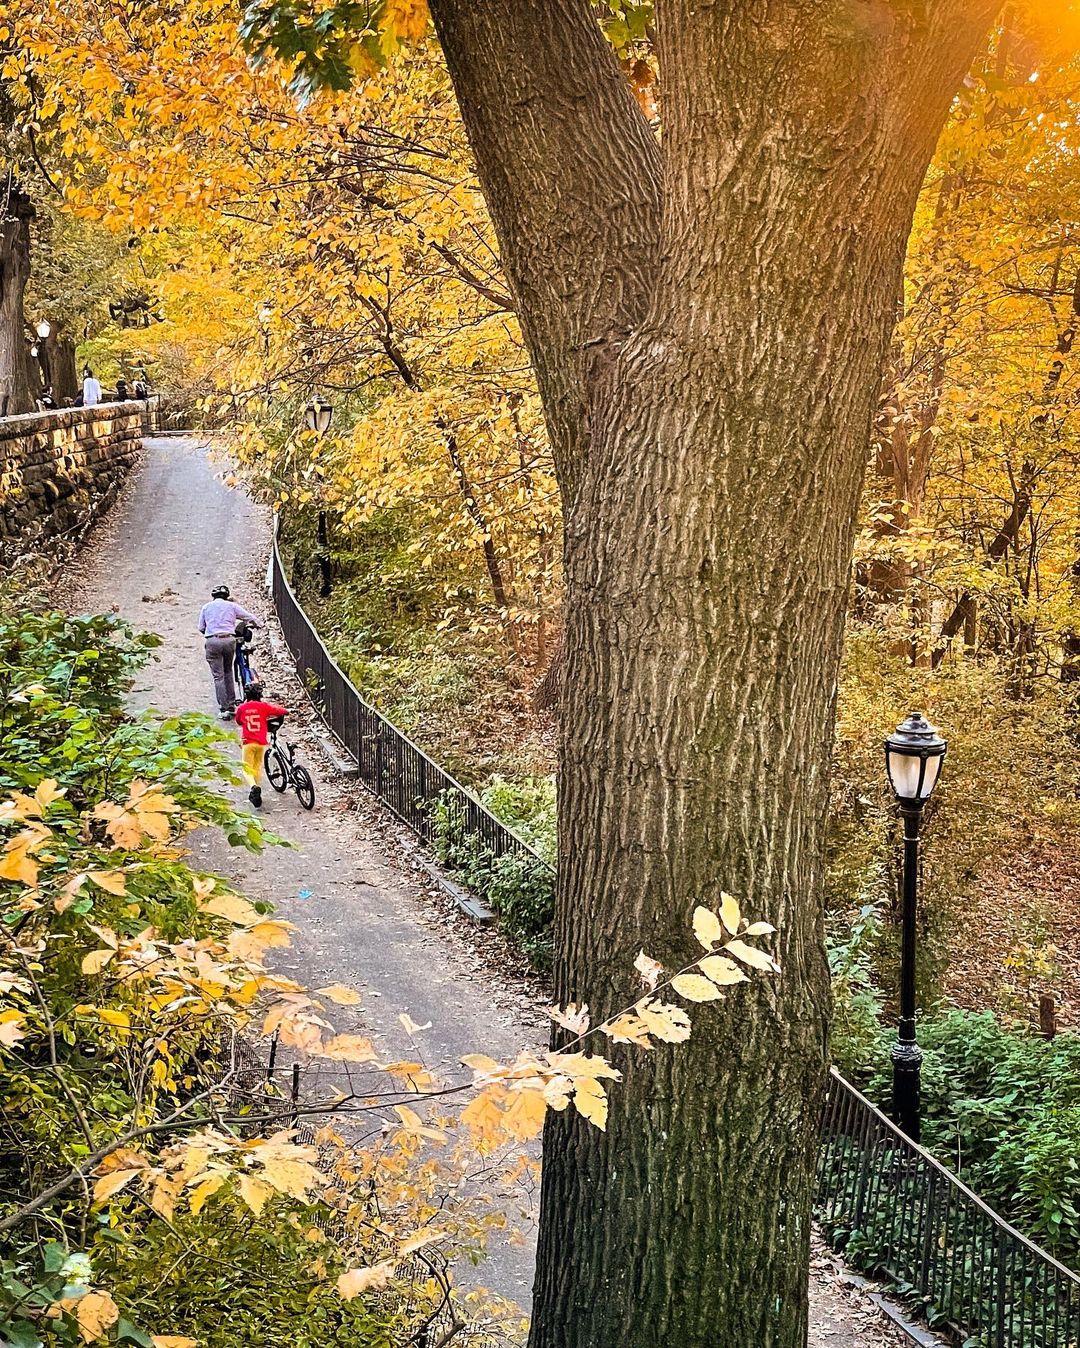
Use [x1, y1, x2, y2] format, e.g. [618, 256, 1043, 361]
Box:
[816, 1072, 1080, 1348]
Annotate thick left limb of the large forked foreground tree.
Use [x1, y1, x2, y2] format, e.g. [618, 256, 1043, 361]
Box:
[431, 0, 662, 504]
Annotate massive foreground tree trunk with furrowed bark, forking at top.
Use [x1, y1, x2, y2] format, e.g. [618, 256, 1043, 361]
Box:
[433, 0, 991, 1348]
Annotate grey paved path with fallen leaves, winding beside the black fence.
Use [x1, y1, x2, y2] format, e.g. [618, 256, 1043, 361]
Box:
[63, 437, 922, 1348]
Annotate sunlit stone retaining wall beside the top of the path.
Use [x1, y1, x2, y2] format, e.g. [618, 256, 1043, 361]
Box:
[0, 402, 154, 572]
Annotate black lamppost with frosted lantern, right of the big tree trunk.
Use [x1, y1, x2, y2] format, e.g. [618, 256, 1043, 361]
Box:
[884, 712, 947, 1142]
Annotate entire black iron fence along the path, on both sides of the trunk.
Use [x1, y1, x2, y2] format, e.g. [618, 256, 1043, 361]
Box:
[270, 517, 1080, 1348]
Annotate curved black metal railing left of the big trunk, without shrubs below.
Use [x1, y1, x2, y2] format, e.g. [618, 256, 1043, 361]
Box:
[270, 514, 550, 869]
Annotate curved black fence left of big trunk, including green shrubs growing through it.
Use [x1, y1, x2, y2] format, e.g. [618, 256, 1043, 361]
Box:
[268, 524, 556, 962]
